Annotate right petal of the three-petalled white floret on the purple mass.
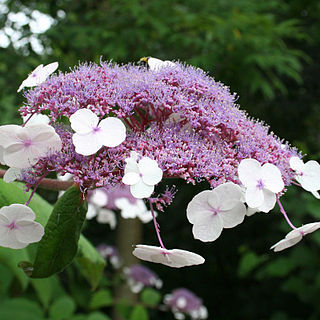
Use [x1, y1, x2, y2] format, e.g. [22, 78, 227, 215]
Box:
[98, 117, 126, 147]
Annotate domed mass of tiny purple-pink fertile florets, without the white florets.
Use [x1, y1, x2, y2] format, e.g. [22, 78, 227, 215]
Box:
[20, 63, 297, 188]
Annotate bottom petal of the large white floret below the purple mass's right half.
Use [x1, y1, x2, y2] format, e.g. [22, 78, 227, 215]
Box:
[192, 214, 223, 242]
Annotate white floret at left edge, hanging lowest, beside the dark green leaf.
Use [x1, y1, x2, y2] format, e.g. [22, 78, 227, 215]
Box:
[0, 204, 44, 249]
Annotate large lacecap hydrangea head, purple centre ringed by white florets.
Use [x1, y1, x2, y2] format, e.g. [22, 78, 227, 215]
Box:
[0, 58, 320, 267]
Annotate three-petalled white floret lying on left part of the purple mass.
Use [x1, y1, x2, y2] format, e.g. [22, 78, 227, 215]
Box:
[70, 109, 126, 156]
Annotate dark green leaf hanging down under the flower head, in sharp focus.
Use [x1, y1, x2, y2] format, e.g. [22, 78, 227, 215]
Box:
[32, 186, 87, 278]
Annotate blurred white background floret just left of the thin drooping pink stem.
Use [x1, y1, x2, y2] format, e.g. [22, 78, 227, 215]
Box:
[114, 197, 157, 223]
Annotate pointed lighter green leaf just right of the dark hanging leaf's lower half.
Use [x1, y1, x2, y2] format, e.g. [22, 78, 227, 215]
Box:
[77, 237, 106, 290]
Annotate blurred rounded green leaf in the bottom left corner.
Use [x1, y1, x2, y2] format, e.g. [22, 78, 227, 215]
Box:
[0, 298, 44, 320]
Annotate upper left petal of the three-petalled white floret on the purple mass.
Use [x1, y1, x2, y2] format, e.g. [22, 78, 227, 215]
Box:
[70, 109, 99, 134]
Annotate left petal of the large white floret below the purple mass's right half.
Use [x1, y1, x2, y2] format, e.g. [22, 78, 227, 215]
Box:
[187, 190, 213, 224]
